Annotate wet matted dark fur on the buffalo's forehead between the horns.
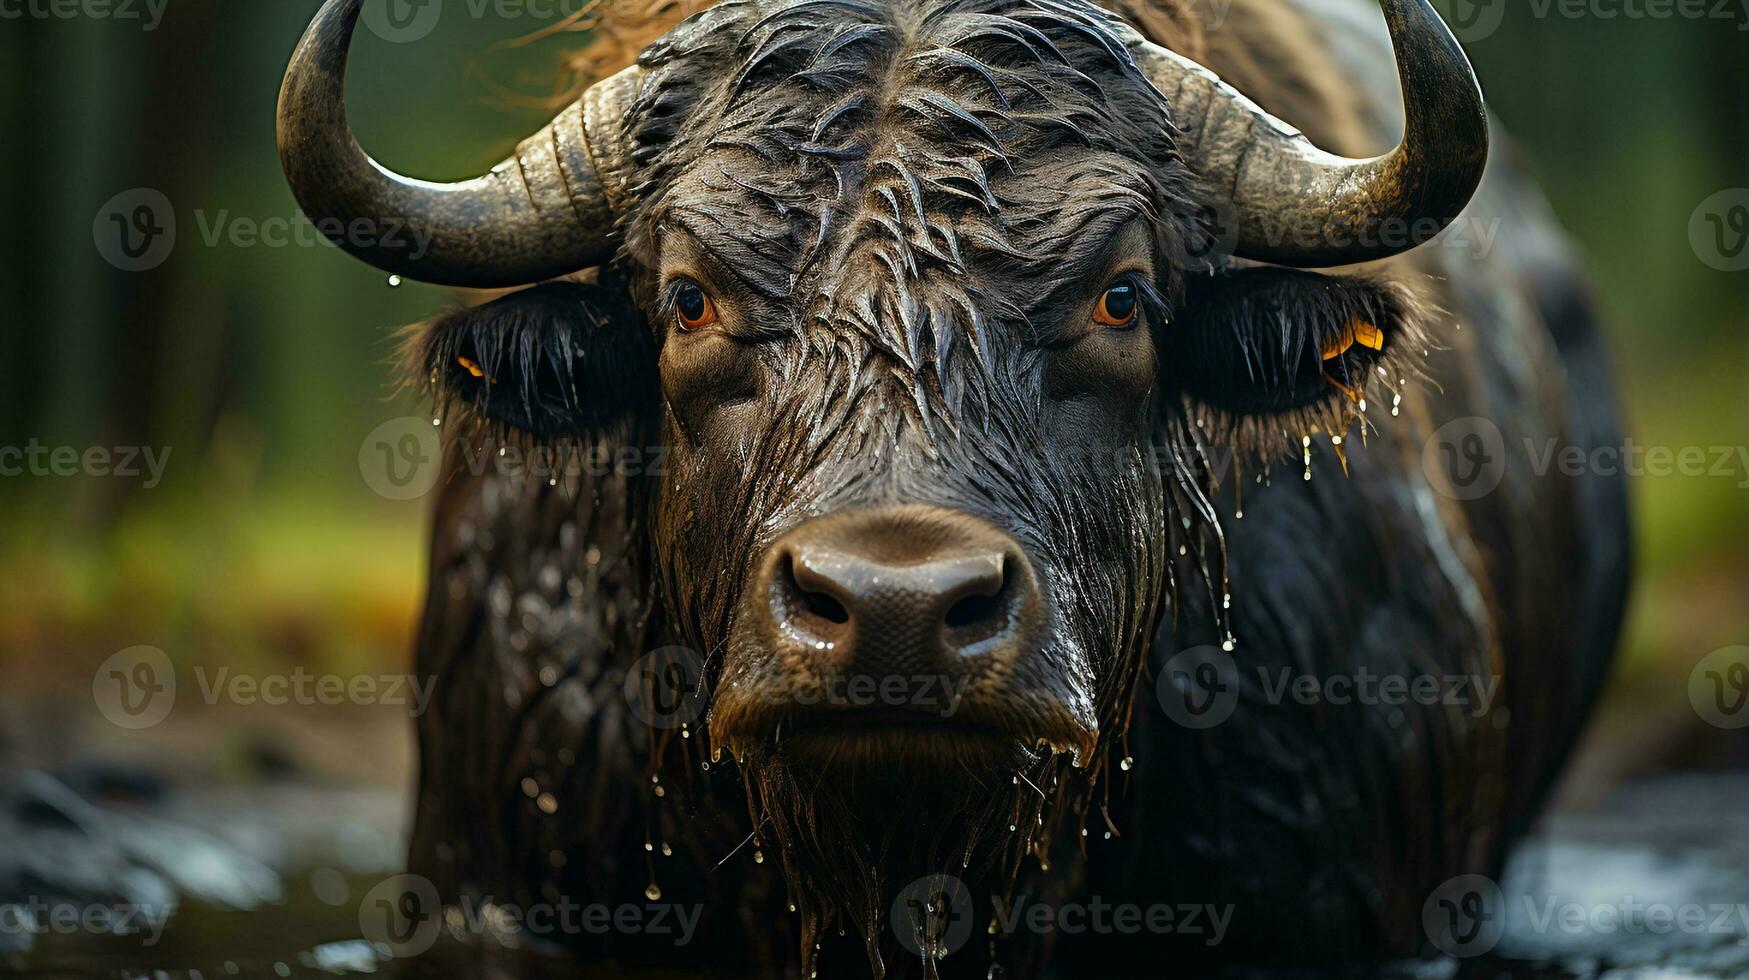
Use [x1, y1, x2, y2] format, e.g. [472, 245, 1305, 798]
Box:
[628, 0, 1188, 355]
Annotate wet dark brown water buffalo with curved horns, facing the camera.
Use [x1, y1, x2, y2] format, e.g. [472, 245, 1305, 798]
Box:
[278, 0, 1627, 977]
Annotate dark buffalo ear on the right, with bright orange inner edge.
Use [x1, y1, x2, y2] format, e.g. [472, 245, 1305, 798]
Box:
[1160, 266, 1422, 420]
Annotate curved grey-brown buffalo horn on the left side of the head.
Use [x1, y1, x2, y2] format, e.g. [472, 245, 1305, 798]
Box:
[278, 0, 640, 287]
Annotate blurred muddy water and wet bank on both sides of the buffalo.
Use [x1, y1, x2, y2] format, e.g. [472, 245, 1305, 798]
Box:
[0, 686, 1749, 980]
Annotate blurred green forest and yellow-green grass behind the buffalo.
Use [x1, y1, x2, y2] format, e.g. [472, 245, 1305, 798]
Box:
[0, 0, 1749, 780]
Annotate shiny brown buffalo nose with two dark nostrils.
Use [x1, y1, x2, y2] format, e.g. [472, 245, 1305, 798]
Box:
[764, 506, 1039, 676]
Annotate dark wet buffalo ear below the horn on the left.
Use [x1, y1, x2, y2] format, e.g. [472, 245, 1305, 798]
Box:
[406, 273, 658, 443]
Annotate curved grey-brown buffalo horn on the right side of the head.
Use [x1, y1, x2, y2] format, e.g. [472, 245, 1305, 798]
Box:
[1137, 0, 1488, 268]
